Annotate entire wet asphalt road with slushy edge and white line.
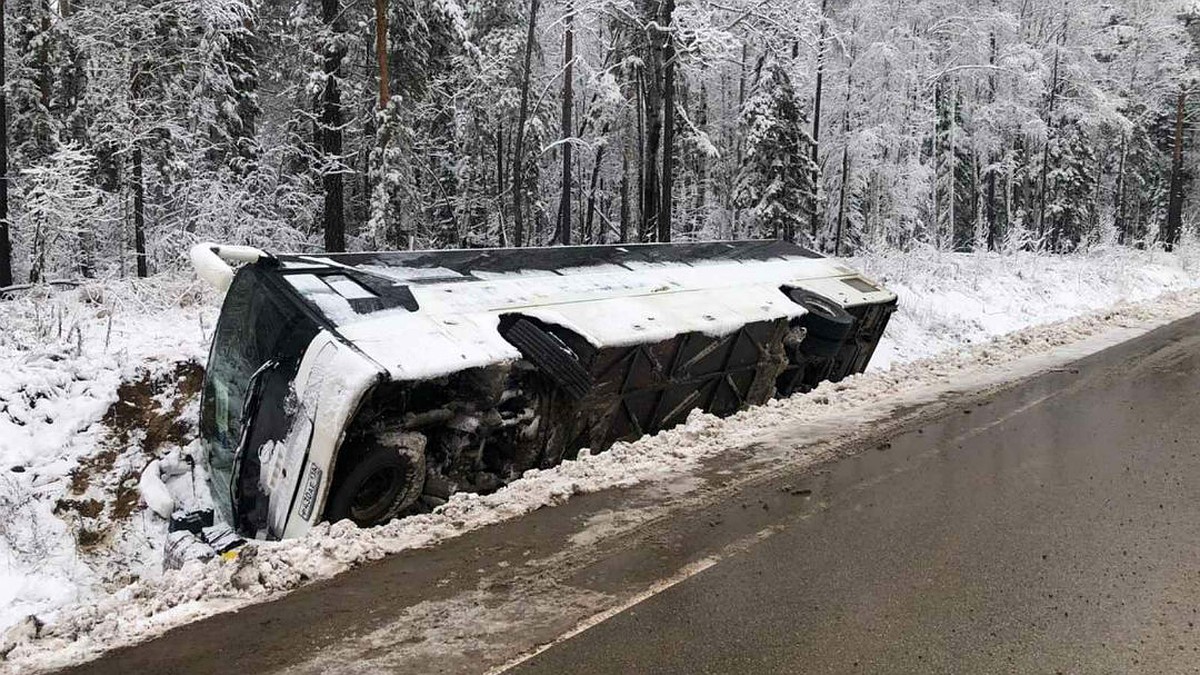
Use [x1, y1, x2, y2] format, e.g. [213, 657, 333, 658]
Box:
[60, 316, 1200, 675]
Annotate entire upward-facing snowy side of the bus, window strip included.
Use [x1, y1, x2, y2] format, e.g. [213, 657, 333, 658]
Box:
[265, 241, 894, 381]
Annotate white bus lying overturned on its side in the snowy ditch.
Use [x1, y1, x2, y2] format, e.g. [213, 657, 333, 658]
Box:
[192, 241, 896, 539]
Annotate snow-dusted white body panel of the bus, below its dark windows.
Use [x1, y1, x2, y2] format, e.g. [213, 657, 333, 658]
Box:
[325, 252, 894, 381]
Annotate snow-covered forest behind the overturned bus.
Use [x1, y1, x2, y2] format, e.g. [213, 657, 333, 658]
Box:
[0, 0, 1200, 287]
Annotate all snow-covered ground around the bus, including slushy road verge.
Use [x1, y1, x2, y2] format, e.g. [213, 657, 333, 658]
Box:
[0, 242, 1200, 670]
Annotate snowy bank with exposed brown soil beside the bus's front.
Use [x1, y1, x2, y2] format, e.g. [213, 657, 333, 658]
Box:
[0, 277, 217, 650]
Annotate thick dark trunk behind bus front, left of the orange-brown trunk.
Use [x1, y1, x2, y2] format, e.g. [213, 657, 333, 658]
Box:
[320, 0, 346, 252]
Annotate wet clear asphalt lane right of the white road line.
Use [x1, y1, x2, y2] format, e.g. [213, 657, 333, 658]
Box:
[511, 321, 1200, 675]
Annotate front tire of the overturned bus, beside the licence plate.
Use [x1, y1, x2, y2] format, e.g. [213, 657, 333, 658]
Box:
[325, 434, 425, 527]
